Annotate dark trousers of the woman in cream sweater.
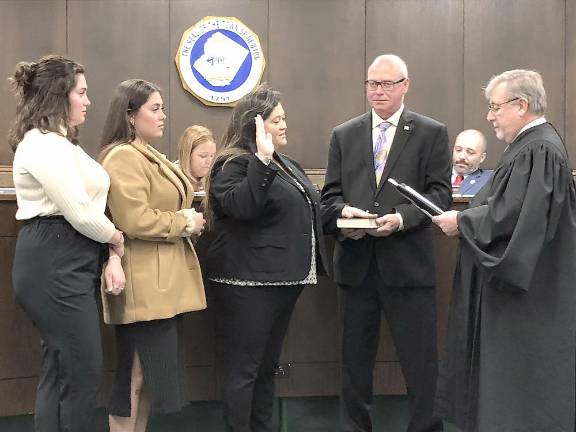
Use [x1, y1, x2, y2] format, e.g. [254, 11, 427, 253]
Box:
[12, 217, 102, 432]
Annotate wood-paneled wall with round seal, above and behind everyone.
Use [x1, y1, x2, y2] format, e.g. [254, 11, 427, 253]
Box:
[0, 0, 576, 168]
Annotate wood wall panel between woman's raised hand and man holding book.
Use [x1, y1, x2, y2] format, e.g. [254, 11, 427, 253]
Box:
[268, 0, 365, 168]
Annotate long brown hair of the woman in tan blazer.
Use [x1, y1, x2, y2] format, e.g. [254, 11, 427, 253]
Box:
[100, 79, 160, 159]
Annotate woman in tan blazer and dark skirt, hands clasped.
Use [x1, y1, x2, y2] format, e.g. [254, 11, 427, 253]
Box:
[102, 80, 206, 432]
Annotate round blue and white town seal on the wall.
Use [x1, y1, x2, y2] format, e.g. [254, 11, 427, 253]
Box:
[175, 16, 266, 106]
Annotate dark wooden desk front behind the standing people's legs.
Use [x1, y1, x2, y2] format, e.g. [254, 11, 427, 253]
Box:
[0, 196, 467, 416]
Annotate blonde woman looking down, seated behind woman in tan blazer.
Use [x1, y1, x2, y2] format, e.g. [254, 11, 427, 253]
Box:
[177, 125, 216, 192]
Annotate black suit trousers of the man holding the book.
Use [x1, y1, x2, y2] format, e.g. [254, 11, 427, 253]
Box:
[340, 261, 443, 432]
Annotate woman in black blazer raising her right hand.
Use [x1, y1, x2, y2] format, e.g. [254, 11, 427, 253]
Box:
[206, 85, 327, 432]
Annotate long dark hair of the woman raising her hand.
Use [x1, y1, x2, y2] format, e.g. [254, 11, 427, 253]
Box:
[202, 83, 280, 228]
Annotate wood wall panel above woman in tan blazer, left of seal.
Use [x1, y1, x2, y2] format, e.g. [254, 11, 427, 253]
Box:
[68, 0, 171, 155]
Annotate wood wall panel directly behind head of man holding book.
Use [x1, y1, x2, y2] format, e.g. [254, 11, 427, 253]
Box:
[366, 0, 463, 140]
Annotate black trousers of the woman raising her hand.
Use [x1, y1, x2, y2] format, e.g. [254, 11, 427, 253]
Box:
[212, 282, 303, 432]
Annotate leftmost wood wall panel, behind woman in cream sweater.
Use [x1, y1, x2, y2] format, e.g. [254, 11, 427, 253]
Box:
[0, 0, 66, 165]
